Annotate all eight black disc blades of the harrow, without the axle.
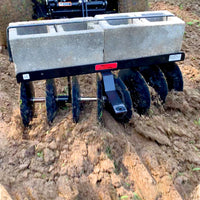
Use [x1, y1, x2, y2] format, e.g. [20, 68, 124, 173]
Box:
[20, 63, 183, 126]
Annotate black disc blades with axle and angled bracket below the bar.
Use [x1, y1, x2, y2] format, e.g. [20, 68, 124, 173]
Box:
[20, 63, 183, 126]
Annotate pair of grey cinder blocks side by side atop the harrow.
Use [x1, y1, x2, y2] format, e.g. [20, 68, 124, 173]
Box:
[9, 11, 185, 78]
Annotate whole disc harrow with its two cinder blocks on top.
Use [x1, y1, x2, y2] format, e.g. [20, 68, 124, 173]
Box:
[7, 11, 185, 126]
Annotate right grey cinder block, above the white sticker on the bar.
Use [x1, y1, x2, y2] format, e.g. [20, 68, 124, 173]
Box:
[95, 11, 185, 62]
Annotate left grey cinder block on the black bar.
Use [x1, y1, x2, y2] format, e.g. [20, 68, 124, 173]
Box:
[9, 17, 104, 74]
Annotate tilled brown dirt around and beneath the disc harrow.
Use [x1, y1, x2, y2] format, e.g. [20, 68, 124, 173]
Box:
[0, 1, 200, 200]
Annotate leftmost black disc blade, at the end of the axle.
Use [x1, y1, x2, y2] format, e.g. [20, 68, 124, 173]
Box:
[20, 82, 34, 126]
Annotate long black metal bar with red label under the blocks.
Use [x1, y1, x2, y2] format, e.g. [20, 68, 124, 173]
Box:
[16, 52, 185, 83]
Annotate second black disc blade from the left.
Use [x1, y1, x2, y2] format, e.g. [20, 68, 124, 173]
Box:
[46, 79, 58, 123]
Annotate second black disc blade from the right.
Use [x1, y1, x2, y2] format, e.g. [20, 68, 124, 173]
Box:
[139, 65, 168, 103]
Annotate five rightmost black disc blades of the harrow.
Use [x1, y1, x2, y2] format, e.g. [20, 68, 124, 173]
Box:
[97, 63, 183, 123]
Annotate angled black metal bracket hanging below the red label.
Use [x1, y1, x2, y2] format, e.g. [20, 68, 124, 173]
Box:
[102, 72, 127, 114]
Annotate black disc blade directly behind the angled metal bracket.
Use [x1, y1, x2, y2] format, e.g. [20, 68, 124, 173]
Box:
[107, 77, 132, 123]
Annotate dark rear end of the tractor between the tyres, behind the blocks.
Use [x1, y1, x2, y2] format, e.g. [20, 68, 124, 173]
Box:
[32, 0, 107, 19]
